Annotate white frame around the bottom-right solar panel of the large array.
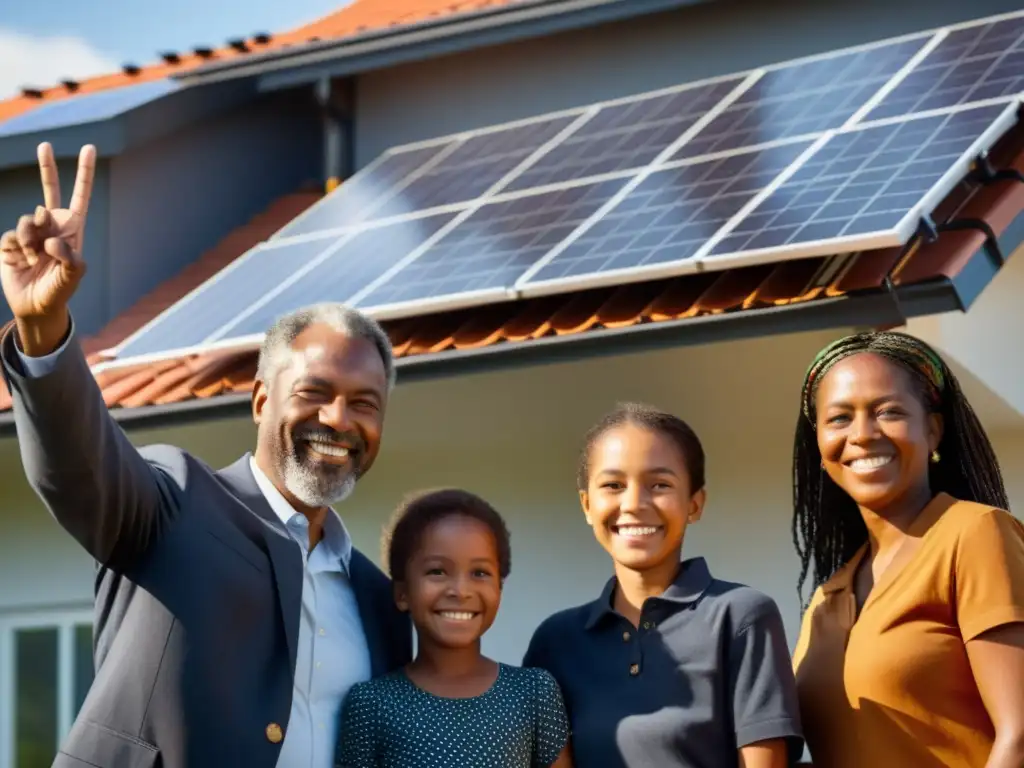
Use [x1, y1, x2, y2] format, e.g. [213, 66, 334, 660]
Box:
[697, 103, 1018, 270]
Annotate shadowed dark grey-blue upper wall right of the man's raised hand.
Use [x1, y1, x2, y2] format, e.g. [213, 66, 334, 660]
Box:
[108, 92, 322, 325]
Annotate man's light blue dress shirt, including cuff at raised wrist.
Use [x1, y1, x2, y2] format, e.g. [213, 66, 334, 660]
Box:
[15, 327, 371, 768]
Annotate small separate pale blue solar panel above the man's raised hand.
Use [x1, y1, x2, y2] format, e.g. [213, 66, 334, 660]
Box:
[0, 80, 180, 136]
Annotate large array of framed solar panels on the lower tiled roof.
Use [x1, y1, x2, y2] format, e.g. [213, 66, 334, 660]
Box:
[115, 13, 1024, 359]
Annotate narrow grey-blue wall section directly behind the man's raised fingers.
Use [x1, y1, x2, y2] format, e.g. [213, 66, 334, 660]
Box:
[0, 157, 111, 329]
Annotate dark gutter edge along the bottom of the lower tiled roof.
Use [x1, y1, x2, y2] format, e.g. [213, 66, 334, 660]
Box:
[0, 272, 978, 437]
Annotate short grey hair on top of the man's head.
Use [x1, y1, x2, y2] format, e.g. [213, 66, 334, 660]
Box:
[256, 303, 395, 391]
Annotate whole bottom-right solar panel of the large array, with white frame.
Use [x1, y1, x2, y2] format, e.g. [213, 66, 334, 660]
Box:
[706, 104, 1016, 268]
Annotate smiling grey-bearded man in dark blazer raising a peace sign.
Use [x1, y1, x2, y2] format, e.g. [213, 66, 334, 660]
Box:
[0, 144, 412, 768]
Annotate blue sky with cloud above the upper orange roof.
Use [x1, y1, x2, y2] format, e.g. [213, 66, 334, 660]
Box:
[0, 0, 346, 98]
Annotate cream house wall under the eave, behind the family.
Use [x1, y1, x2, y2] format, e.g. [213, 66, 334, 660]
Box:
[0, 333, 1024, 663]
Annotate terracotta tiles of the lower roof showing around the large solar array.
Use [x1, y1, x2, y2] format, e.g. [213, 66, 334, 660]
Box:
[0, 131, 1024, 421]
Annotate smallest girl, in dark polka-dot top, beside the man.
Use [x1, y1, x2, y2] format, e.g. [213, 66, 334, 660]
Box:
[340, 489, 571, 768]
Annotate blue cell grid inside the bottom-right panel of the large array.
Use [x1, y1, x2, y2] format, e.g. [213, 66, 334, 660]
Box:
[709, 104, 1007, 262]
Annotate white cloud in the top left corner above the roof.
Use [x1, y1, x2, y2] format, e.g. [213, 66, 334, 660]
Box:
[0, 29, 120, 98]
